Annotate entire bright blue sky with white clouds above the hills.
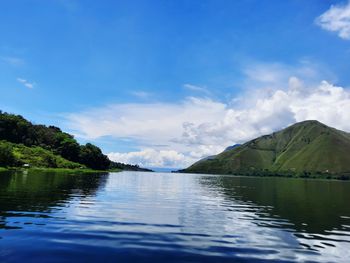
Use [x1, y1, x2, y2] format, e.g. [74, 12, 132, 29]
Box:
[0, 0, 350, 166]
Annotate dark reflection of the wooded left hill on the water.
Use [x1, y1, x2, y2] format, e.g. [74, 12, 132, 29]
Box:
[0, 171, 107, 229]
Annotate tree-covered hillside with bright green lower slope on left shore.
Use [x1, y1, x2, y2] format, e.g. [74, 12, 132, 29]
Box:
[0, 111, 150, 170]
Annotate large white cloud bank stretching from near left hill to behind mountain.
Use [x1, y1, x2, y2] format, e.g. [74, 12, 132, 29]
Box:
[68, 64, 350, 167]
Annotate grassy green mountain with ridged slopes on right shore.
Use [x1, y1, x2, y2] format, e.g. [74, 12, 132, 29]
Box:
[180, 121, 350, 178]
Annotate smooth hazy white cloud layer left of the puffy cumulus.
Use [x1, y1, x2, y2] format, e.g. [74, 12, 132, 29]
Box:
[68, 98, 226, 144]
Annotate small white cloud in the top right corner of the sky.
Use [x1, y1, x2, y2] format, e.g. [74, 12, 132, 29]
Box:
[316, 1, 350, 39]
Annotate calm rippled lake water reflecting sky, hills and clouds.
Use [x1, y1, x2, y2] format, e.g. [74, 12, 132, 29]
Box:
[0, 172, 350, 262]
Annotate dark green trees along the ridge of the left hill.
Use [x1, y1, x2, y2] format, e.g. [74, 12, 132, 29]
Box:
[0, 111, 112, 170]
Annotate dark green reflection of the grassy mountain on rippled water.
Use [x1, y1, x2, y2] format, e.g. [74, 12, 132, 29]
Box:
[203, 177, 350, 233]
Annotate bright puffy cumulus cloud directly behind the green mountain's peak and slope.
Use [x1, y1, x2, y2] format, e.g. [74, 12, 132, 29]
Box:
[178, 77, 350, 150]
